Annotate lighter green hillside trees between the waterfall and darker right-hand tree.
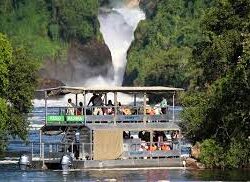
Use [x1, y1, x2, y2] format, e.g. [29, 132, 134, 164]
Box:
[123, 0, 211, 87]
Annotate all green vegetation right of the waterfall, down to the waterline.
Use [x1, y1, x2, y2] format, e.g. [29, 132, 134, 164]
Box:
[127, 0, 250, 168]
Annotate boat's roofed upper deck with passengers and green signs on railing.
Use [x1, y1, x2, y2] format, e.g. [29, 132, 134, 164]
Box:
[38, 86, 184, 130]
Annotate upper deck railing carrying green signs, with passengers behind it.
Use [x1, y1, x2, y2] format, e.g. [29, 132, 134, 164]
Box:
[43, 106, 179, 124]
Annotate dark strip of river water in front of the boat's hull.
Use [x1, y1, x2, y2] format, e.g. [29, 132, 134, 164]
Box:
[0, 165, 250, 182]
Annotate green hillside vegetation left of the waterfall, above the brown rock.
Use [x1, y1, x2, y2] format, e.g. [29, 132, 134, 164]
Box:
[0, 0, 101, 61]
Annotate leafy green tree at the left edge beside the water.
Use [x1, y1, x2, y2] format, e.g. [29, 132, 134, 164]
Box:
[0, 33, 38, 151]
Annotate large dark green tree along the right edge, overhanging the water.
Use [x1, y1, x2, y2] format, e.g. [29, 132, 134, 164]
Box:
[183, 0, 250, 167]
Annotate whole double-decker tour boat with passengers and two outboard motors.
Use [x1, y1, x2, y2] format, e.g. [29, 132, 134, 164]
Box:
[19, 86, 188, 170]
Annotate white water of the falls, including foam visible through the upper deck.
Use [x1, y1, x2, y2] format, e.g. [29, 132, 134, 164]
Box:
[33, 0, 145, 107]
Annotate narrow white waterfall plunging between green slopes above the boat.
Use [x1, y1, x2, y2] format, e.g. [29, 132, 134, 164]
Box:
[98, 1, 145, 86]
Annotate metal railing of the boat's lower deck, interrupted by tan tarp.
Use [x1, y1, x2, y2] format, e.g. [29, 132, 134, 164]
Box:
[26, 141, 188, 162]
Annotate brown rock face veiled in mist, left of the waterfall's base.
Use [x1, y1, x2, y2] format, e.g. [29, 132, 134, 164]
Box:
[39, 40, 113, 86]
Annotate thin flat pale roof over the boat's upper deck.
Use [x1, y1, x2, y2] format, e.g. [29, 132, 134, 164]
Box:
[37, 86, 184, 96]
